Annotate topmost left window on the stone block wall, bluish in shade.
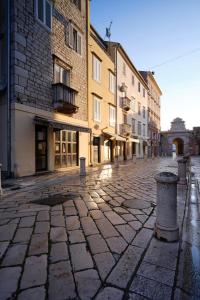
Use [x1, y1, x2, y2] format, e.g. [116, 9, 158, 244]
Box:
[35, 0, 52, 29]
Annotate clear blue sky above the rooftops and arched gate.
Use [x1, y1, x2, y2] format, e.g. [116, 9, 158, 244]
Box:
[90, 0, 200, 130]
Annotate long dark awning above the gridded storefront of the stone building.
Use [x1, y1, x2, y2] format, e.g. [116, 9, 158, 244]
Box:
[34, 116, 91, 132]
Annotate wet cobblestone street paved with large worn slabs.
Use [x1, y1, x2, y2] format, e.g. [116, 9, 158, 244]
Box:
[0, 158, 200, 300]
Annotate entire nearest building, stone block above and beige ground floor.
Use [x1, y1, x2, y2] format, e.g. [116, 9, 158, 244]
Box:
[0, 0, 90, 176]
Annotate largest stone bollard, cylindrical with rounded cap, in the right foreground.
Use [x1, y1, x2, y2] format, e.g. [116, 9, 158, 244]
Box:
[154, 172, 179, 242]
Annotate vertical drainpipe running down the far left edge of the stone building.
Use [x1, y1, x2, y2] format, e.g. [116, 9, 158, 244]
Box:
[7, 0, 11, 177]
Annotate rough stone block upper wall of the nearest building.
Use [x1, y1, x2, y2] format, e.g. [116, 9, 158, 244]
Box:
[11, 0, 88, 121]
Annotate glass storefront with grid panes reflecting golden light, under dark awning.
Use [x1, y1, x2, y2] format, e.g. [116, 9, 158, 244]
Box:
[55, 130, 78, 169]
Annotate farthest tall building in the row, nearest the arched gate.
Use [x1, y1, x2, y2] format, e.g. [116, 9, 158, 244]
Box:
[140, 71, 162, 157]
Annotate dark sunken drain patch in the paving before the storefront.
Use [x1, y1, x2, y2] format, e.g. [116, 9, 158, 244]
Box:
[31, 193, 78, 206]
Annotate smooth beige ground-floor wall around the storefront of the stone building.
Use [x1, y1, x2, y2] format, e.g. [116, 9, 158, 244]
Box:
[12, 104, 89, 177]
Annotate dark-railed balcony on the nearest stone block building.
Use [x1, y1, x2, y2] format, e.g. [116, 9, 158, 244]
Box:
[53, 83, 79, 114]
